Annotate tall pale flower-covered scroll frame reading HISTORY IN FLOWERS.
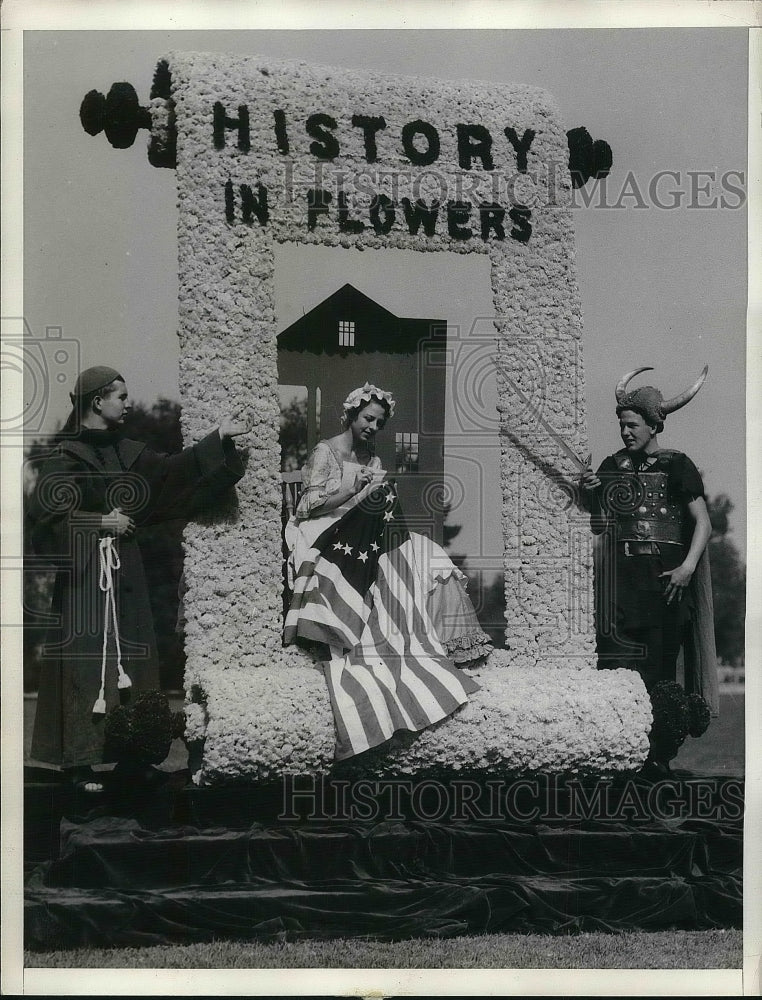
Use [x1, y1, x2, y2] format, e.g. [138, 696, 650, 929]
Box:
[83, 53, 650, 781]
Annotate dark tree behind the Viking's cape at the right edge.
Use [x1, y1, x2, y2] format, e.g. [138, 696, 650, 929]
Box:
[707, 493, 746, 666]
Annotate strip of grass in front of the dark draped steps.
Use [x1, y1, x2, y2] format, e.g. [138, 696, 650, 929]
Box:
[24, 930, 742, 969]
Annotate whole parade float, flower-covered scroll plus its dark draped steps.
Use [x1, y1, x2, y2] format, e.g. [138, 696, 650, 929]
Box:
[26, 52, 742, 948]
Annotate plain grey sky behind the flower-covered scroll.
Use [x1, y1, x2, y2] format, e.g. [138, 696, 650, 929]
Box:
[24, 29, 748, 553]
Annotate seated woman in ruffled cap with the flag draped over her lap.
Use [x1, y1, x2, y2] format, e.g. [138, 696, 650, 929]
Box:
[284, 382, 491, 760]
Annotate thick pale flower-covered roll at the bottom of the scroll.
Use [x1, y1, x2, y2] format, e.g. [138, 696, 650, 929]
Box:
[186, 650, 652, 784]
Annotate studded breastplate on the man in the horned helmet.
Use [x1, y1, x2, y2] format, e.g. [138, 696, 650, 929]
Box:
[612, 456, 684, 545]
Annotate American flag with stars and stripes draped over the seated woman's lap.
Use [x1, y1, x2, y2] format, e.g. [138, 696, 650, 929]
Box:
[284, 482, 478, 760]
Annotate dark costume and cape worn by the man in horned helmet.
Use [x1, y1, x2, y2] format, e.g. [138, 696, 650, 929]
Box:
[591, 449, 717, 711]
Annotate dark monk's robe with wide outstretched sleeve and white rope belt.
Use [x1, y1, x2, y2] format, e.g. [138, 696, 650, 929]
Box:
[29, 430, 243, 768]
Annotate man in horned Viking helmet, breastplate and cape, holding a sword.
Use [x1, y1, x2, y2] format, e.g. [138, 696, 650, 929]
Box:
[581, 367, 719, 715]
